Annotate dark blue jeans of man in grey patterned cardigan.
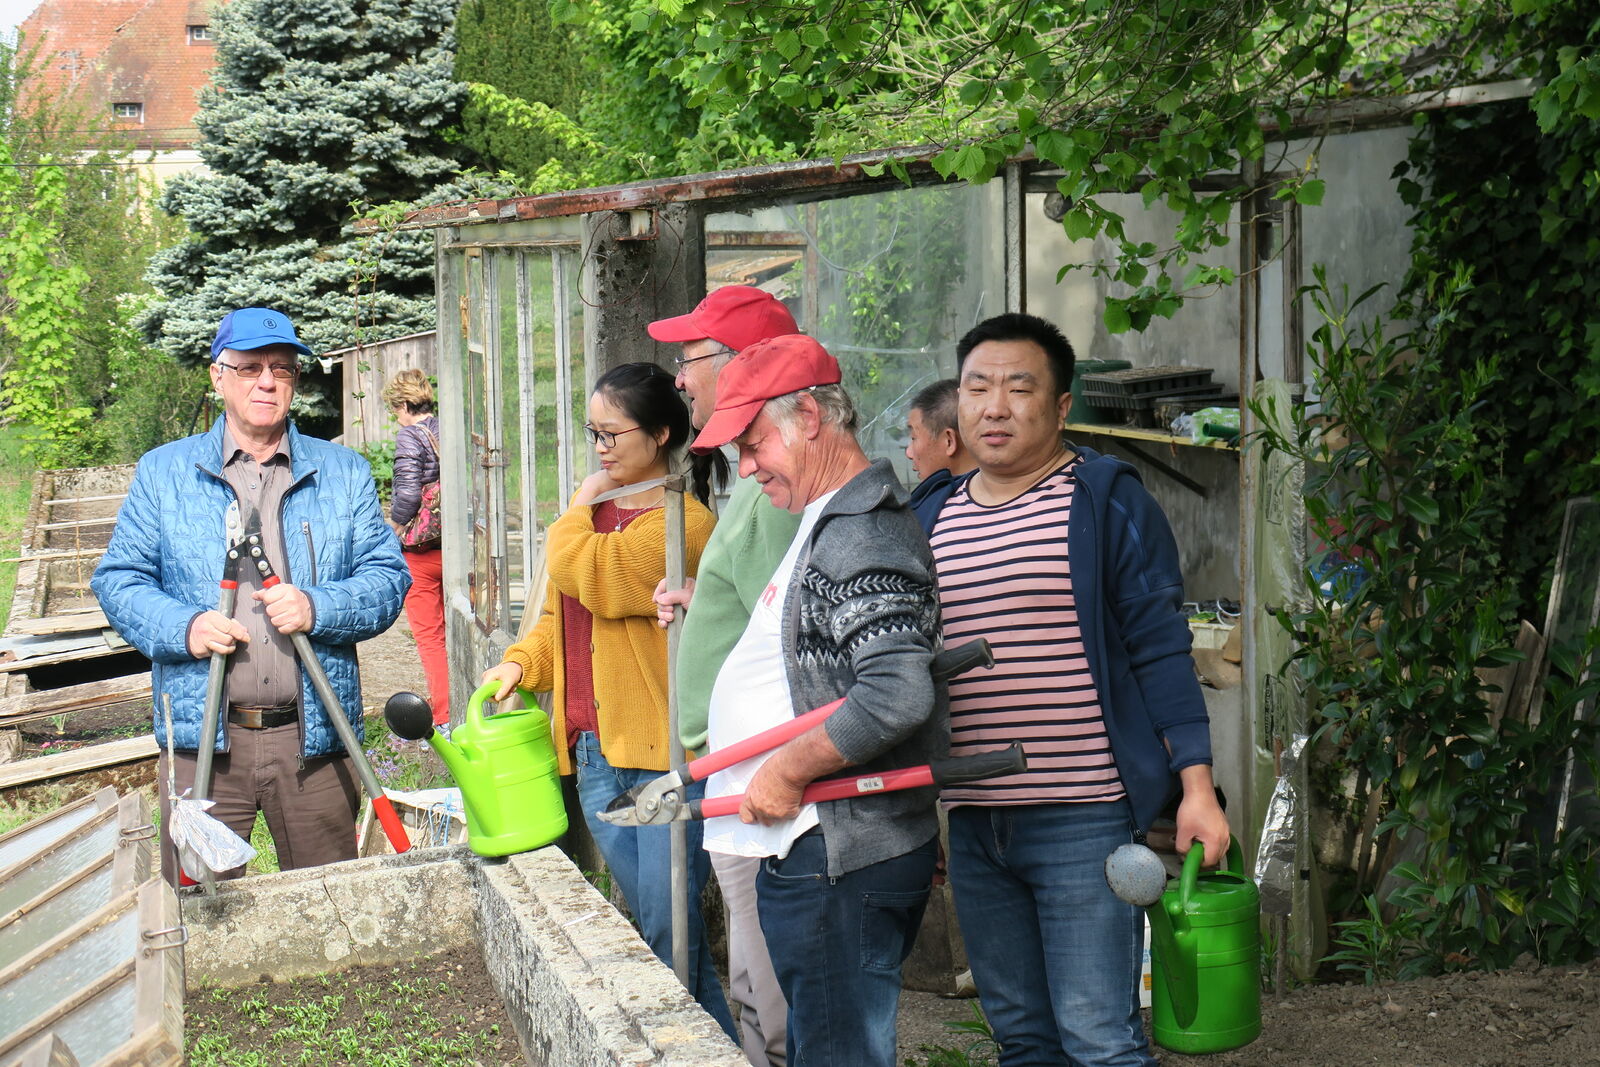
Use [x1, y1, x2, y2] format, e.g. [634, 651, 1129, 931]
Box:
[755, 829, 938, 1067]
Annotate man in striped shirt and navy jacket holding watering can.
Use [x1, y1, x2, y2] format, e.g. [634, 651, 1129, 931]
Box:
[918, 315, 1229, 1067]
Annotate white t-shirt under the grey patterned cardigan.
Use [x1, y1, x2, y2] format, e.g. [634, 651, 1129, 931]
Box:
[706, 490, 837, 859]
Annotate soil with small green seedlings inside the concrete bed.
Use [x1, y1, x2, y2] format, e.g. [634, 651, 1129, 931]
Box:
[184, 949, 523, 1067]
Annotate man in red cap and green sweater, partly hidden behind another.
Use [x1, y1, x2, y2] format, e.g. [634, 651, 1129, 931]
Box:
[648, 285, 798, 1067]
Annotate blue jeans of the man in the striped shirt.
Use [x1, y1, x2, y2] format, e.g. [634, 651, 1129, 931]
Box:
[949, 800, 1155, 1067]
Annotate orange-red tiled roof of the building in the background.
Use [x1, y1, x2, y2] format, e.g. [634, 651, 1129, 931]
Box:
[21, 0, 216, 149]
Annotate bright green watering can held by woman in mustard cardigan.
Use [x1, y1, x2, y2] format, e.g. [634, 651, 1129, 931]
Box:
[384, 681, 566, 856]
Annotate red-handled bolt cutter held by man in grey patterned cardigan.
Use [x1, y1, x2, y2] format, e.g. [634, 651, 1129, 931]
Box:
[598, 638, 1027, 825]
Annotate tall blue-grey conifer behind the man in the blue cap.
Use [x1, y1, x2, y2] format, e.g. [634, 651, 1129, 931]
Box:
[141, 0, 464, 362]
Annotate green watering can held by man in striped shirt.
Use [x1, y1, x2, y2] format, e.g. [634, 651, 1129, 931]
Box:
[1106, 838, 1261, 1054]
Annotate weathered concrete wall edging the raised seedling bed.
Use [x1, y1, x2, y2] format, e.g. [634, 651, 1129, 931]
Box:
[184, 846, 746, 1067]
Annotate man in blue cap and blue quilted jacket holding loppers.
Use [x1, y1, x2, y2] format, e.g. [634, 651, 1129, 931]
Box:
[93, 307, 411, 883]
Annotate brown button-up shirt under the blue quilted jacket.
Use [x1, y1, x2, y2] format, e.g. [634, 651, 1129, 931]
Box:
[222, 424, 299, 707]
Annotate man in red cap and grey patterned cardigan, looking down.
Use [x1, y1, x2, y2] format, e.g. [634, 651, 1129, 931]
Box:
[685, 334, 949, 1067]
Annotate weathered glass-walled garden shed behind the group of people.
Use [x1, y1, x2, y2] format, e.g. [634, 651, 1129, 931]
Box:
[387, 73, 1528, 979]
